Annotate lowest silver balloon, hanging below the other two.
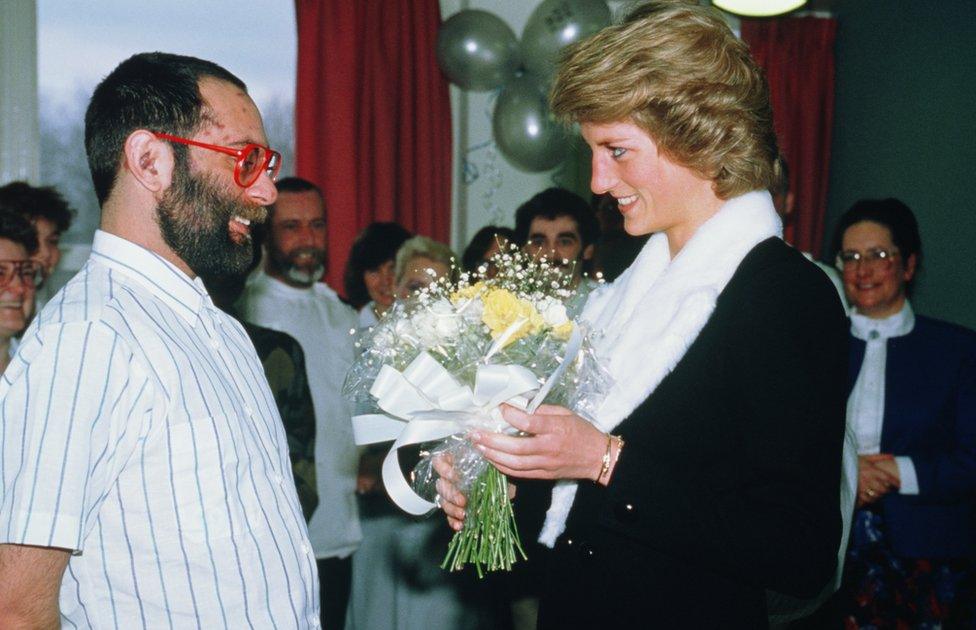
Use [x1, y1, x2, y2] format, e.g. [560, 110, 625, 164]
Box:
[491, 75, 569, 172]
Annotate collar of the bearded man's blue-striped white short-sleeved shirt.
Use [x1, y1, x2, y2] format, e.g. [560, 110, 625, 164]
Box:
[91, 230, 217, 325]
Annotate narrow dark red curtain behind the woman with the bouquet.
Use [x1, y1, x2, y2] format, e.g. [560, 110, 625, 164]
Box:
[742, 17, 837, 256]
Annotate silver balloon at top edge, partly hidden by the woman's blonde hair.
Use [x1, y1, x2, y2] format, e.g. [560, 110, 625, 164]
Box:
[521, 0, 610, 83]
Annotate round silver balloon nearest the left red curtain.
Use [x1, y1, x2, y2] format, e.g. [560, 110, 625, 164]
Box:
[437, 9, 519, 92]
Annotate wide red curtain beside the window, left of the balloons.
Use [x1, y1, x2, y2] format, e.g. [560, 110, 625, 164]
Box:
[295, 0, 451, 289]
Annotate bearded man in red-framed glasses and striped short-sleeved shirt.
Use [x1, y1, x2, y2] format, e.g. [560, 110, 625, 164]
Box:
[0, 53, 318, 628]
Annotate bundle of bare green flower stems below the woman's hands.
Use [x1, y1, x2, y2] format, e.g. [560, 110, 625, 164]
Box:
[441, 466, 527, 578]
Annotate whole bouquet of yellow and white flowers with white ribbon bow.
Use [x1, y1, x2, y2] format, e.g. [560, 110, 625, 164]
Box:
[343, 247, 610, 576]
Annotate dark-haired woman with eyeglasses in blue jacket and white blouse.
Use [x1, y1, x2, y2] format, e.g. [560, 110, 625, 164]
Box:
[834, 199, 976, 628]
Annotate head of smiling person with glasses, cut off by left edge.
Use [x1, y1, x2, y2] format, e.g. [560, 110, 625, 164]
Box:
[0, 205, 41, 374]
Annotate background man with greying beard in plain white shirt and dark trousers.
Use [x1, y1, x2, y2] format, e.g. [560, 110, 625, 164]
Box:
[238, 177, 362, 630]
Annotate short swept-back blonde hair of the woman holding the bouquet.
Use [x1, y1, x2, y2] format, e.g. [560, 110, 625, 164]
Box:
[550, 0, 779, 199]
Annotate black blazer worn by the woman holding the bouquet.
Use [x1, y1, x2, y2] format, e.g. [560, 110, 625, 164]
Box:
[540, 238, 848, 629]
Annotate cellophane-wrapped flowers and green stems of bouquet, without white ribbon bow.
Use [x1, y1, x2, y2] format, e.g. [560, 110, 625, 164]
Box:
[343, 248, 611, 575]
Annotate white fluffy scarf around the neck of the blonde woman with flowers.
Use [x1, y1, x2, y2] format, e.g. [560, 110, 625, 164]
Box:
[539, 192, 783, 547]
